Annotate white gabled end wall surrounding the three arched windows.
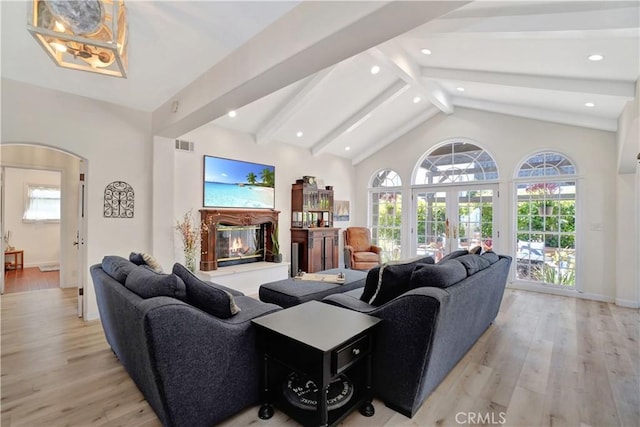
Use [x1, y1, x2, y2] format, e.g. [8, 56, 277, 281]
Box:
[354, 108, 624, 302]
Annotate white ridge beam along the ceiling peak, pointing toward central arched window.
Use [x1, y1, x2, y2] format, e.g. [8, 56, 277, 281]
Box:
[369, 42, 453, 114]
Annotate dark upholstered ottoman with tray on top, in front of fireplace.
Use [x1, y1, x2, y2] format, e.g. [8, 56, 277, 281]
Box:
[258, 268, 367, 308]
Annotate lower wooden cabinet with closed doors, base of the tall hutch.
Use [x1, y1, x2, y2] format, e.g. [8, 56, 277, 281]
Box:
[291, 227, 340, 274]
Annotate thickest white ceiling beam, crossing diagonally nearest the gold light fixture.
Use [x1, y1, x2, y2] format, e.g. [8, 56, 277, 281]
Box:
[151, 1, 469, 138]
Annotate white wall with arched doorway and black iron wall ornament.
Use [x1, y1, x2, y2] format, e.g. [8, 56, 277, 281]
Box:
[0, 79, 152, 319]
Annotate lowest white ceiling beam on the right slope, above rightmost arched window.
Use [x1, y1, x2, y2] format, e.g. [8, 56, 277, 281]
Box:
[453, 97, 618, 132]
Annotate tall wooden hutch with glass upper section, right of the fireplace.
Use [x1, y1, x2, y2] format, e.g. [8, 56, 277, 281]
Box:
[291, 176, 339, 274]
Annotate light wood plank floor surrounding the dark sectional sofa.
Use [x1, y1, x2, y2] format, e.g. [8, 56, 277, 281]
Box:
[1, 289, 640, 427]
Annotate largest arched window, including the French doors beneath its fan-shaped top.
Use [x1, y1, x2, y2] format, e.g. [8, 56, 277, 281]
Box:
[412, 139, 498, 261]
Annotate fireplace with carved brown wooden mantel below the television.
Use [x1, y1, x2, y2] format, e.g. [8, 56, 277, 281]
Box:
[200, 209, 279, 271]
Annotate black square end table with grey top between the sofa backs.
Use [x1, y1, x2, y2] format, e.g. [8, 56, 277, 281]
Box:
[252, 301, 381, 426]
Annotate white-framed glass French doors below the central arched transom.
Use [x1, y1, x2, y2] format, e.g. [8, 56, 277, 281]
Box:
[411, 184, 499, 262]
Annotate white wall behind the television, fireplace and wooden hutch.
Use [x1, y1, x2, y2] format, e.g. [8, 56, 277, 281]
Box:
[154, 125, 354, 268]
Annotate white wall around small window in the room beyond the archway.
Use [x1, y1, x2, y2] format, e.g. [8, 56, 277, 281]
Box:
[4, 168, 61, 268]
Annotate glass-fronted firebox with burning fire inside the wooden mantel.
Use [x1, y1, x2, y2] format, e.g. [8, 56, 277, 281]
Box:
[216, 224, 265, 267]
